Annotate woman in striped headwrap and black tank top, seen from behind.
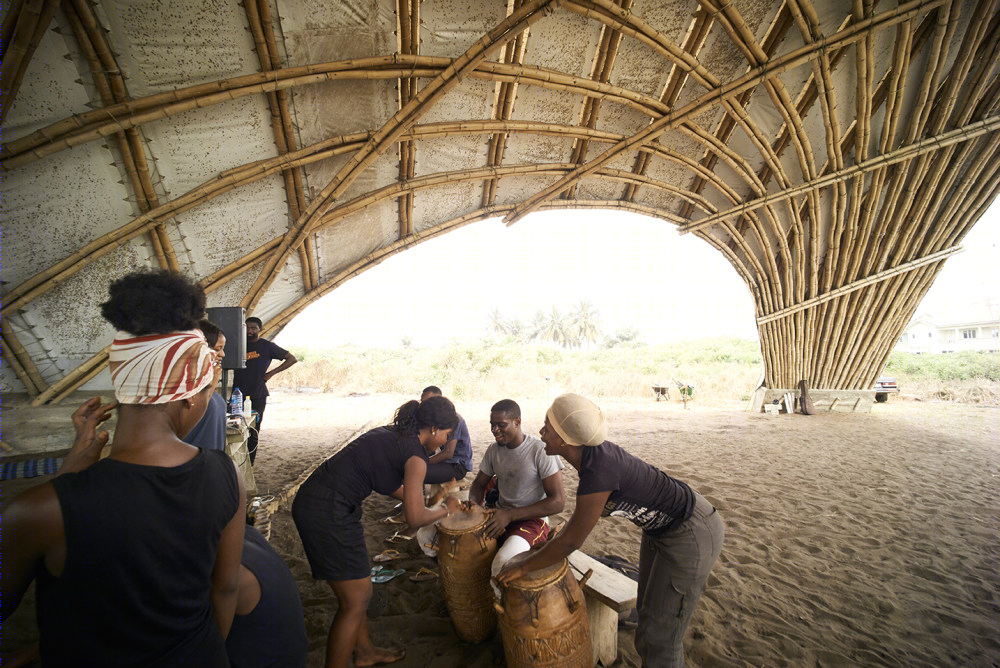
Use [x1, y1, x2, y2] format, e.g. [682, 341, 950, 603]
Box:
[0, 271, 245, 667]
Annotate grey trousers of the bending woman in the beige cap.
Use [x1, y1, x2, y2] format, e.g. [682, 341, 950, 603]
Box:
[635, 492, 726, 668]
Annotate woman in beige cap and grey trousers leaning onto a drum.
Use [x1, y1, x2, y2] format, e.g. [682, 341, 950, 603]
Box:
[497, 394, 725, 668]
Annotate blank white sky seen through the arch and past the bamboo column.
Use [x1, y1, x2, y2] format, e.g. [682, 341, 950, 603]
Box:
[277, 205, 1000, 348]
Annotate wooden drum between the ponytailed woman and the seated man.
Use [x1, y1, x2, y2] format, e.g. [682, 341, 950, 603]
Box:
[438, 506, 497, 643]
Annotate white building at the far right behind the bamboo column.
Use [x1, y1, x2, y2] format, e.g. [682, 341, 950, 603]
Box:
[895, 302, 1000, 353]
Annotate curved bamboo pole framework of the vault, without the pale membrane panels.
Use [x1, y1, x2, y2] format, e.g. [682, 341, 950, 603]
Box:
[0, 0, 1000, 403]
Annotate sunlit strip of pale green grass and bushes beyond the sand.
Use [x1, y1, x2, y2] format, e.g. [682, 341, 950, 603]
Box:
[270, 338, 1000, 406]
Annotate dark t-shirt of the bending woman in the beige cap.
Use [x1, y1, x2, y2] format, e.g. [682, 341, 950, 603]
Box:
[576, 441, 694, 534]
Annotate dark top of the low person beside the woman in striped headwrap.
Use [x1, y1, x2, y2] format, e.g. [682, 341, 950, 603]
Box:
[226, 526, 309, 668]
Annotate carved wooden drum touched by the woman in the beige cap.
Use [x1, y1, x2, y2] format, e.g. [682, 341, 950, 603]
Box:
[497, 559, 593, 668]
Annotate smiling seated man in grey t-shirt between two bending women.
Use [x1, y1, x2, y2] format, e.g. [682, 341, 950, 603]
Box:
[469, 399, 565, 575]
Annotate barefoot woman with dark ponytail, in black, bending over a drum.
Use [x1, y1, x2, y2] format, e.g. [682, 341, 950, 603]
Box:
[292, 397, 461, 668]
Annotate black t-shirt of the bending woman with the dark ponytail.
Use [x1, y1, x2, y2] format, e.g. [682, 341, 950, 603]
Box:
[302, 427, 427, 505]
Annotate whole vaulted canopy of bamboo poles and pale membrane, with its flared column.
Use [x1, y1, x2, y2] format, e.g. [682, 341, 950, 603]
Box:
[0, 0, 1000, 403]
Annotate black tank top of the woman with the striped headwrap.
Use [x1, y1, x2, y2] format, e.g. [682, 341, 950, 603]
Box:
[36, 450, 239, 667]
